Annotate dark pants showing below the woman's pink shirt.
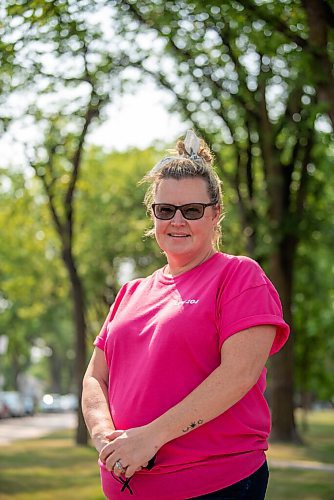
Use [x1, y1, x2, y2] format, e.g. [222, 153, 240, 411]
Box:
[190, 462, 269, 500]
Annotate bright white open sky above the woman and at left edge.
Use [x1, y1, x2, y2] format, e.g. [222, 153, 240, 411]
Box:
[0, 82, 191, 167]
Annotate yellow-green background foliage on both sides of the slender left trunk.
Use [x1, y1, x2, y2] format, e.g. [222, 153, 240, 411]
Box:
[0, 147, 161, 406]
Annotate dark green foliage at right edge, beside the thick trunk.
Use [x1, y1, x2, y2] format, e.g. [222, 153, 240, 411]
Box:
[293, 135, 334, 414]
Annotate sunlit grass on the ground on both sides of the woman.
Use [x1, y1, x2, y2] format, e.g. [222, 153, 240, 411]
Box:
[0, 411, 334, 500]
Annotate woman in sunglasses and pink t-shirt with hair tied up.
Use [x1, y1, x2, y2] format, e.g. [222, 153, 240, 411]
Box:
[83, 131, 289, 500]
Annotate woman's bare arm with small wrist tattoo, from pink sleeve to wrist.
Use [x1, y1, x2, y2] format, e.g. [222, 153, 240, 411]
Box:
[149, 325, 275, 446]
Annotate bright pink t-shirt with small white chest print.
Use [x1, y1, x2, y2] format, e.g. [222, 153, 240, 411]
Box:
[94, 253, 289, 500]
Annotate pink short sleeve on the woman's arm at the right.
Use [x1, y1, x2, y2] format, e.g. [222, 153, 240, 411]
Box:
[219, 259, 290, 355]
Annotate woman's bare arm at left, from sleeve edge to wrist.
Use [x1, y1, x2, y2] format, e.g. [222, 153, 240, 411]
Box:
[82, 347, 115, 453]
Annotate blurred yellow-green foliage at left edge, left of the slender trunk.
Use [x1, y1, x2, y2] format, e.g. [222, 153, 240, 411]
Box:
[0, 169, 73, 392]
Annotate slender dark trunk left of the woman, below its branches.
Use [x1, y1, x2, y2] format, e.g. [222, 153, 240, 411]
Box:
[62, 248, 88, 445]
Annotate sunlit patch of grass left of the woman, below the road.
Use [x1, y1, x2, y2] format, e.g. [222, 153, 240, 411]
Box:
[0, 431, 105, 500]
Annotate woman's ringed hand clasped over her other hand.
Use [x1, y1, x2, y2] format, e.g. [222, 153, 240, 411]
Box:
[100, 426, 161, 477]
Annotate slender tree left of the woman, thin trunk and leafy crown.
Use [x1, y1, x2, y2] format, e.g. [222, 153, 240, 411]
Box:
[3, 0, 144, 444]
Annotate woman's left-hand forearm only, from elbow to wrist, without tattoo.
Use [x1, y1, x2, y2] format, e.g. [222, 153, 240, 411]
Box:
[82, 374, 115, 452]
